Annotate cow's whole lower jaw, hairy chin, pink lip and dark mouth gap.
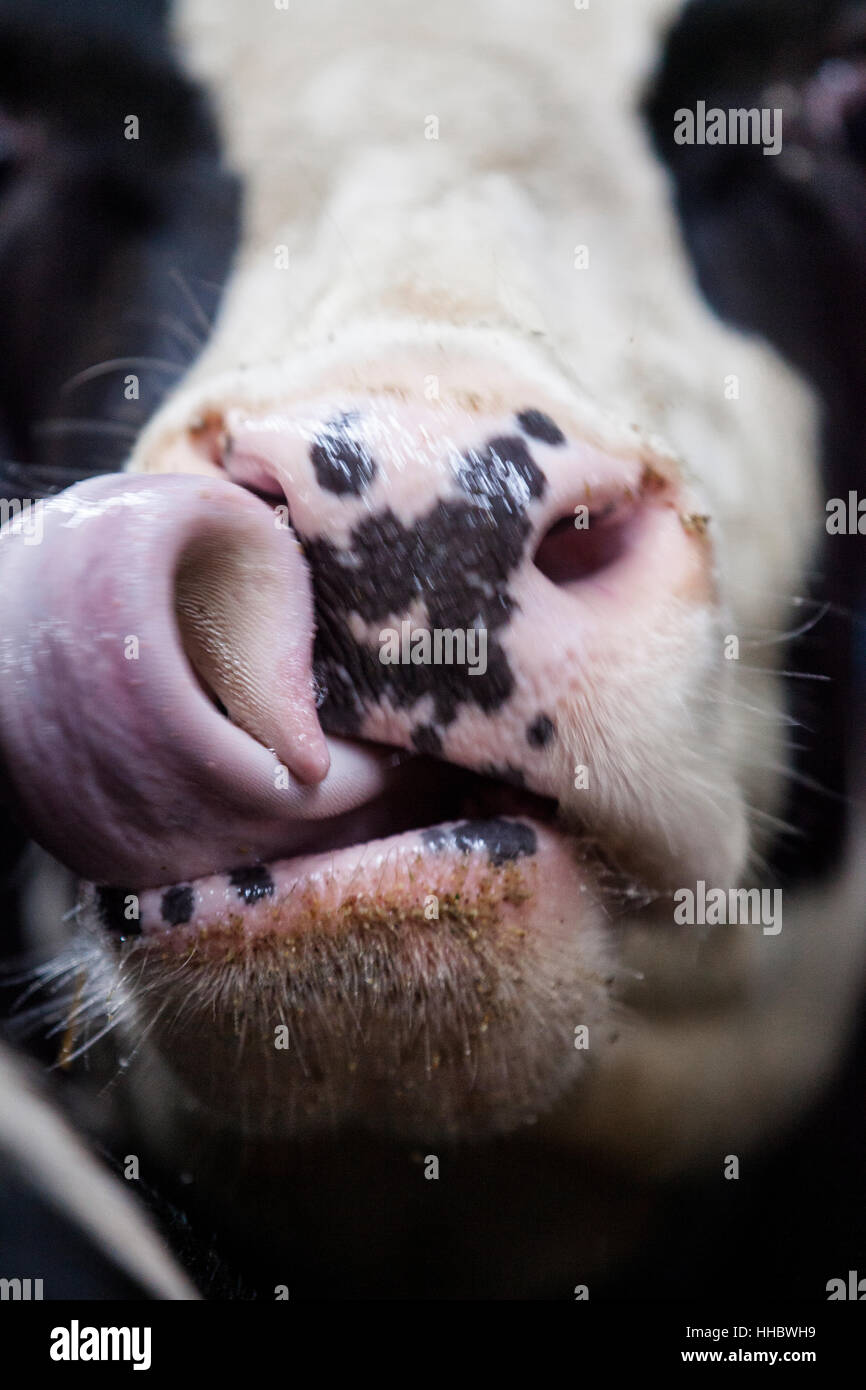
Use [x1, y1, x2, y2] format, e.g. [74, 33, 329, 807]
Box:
[76, 756, 612, 1138]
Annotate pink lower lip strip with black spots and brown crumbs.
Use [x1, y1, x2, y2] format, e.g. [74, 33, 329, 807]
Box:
[89, 816, 594, 960]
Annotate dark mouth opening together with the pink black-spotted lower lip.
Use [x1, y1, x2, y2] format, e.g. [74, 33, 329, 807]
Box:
[86, 753, 603, 960]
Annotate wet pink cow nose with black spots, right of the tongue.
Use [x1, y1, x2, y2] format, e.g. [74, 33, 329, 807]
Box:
[209, 393, 709, 795]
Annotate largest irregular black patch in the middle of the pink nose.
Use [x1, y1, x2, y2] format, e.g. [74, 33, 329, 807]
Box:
[300, 436, 546, 752]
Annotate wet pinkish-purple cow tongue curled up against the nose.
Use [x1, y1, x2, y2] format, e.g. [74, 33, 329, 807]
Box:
[0, 475, 385, 888]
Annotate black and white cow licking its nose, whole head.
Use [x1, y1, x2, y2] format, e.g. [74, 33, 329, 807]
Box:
[0, 0, 866, 1297]
